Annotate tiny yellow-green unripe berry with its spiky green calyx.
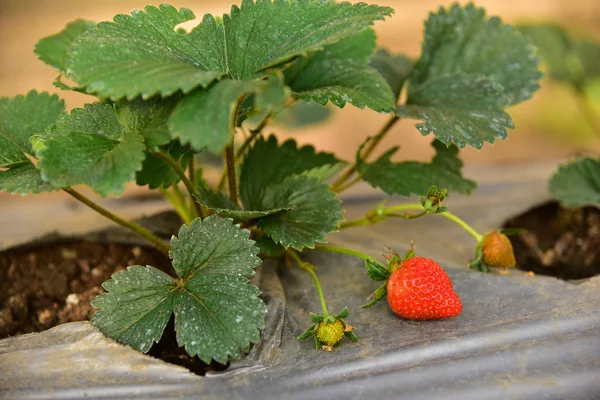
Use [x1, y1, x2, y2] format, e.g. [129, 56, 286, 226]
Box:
[298, 307, 358, 351]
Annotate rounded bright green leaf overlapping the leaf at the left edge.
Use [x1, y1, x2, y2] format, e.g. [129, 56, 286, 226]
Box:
[37, 103, 145, 196]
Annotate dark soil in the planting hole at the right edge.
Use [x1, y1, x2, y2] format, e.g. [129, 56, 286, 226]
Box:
[504, 202, 600, 280]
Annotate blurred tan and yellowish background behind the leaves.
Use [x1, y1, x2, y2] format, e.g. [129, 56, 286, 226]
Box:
[0, 0, 600, 244]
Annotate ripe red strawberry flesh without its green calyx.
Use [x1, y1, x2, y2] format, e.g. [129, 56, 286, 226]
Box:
[387, 257, 462, 320]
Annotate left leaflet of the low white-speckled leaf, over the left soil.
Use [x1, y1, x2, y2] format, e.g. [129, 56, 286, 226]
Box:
[91, 265, 176, 353]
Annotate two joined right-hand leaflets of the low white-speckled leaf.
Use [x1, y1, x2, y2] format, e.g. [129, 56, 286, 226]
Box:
[171, 215, 266, 363]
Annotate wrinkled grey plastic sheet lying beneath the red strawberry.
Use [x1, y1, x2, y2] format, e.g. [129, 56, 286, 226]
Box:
[0, 161, 600, 400]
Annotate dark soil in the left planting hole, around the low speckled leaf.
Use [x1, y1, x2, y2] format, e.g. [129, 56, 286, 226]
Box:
[0, 241, 226, 375]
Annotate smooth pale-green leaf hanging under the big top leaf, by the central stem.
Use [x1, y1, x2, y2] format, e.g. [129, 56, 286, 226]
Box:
[169, 79, 260, 153]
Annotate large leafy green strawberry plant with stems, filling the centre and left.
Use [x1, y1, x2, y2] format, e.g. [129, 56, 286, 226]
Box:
[0, 0, 541, 363]
